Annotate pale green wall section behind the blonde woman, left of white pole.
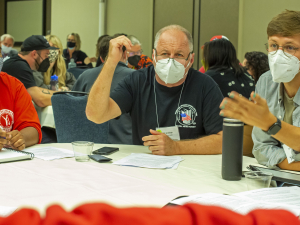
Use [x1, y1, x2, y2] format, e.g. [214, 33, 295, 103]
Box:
[51, 0, 99, 57]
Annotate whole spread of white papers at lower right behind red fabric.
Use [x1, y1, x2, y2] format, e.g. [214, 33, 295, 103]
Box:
[171, 187, 300, 216]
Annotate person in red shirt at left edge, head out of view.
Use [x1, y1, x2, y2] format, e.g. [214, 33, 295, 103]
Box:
[0, 47, 42, 151]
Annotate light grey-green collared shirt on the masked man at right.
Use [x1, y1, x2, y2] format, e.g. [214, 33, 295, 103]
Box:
[252, 71, 300, 168]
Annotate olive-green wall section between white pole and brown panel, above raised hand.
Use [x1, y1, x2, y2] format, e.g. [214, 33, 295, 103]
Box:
[106, 0, 153, 59]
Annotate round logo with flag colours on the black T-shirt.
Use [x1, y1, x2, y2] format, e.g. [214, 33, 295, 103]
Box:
[175, 104, 197, 128]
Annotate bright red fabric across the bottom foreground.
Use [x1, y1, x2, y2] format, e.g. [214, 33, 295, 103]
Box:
[0, 203, 300, 225]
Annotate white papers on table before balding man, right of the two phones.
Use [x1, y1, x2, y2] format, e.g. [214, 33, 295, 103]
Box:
[113, 153, 183, 169]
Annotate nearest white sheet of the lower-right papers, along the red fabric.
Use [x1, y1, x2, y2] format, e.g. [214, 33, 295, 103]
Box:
[171, 187, 300, 216]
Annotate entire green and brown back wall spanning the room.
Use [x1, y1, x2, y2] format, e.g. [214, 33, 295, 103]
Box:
[4, 0, 300, 66]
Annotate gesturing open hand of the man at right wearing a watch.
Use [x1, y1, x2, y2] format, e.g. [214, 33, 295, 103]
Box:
[220, 91, 277, 131]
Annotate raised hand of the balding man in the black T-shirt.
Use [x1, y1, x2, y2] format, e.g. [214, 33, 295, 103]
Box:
[107, 36, 132, 64]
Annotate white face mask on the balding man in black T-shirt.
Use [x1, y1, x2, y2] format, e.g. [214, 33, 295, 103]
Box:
[154, 56, 190, 84]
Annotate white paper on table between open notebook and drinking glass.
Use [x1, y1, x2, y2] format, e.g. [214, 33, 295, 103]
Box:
[26, 147, 74, 160]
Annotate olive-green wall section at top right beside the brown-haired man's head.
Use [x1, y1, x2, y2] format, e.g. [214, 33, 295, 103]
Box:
[238, 0, 300, 60]
